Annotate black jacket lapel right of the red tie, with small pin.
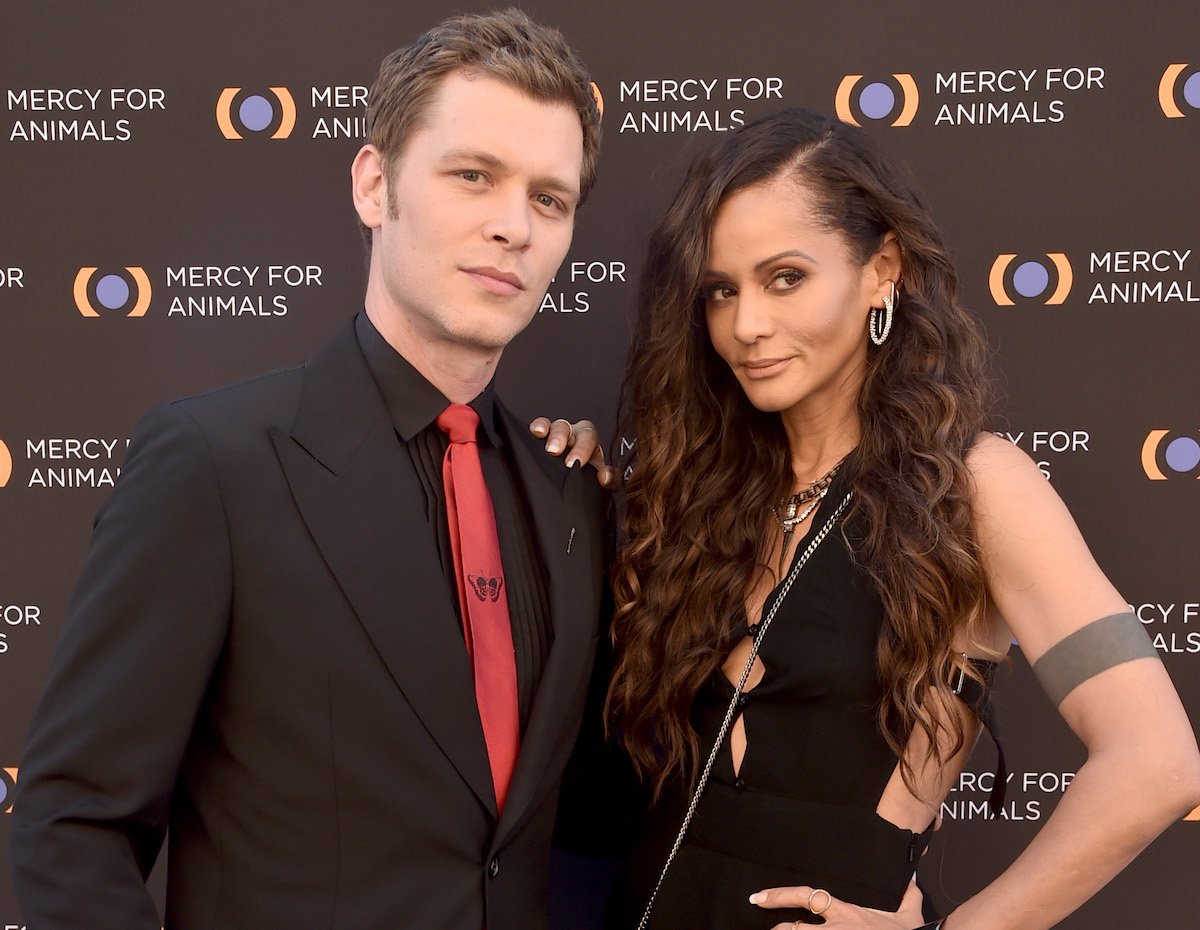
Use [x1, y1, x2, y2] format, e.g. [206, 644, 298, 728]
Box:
[494, 404, 598, 845]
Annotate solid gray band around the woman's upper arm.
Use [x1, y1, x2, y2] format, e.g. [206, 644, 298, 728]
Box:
[1033, 612, 1158, 707]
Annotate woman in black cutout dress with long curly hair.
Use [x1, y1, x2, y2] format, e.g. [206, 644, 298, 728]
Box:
[607, 109, 1200, 930]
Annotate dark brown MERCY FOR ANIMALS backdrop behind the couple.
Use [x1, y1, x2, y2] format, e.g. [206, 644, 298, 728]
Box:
[0, 0, 1200, 930]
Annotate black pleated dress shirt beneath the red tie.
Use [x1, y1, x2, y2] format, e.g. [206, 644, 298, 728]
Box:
[355, 313, 553, 736]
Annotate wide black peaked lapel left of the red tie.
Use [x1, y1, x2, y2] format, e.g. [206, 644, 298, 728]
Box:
[272, 325, 496, 815]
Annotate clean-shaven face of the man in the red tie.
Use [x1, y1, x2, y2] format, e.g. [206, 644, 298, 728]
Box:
[360, 73, 583, 352]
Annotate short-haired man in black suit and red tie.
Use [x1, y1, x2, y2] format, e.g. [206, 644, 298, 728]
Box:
[12, 11, 604, 930]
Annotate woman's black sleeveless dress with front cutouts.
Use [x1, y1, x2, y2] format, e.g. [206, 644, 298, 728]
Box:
[606, 468, 993, 930]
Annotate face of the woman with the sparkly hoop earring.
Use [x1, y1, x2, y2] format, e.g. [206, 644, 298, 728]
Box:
[702, 179, 888, 415]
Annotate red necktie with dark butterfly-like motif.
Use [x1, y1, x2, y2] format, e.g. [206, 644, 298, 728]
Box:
[438, 403, 521, 812]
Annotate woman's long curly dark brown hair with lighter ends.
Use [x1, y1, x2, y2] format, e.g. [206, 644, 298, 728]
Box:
[606, 108, 990, 794]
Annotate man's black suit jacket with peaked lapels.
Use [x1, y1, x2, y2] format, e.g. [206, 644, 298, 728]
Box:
[12, 326, 604, 930]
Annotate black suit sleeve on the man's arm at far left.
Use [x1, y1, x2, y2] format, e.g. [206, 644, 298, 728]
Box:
[12, 406, 232, 930]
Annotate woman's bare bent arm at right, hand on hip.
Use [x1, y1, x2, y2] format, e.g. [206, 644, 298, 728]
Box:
[947, 436, 1200, 930]
